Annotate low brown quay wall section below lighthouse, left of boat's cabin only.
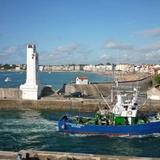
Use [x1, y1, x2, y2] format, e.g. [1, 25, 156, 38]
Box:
[0, 98, 100, 112]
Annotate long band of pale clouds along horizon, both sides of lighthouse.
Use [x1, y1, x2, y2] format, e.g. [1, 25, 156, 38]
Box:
[0, 41, 160, 64]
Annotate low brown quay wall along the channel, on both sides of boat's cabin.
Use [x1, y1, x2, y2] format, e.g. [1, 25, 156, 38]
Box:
[0, 98, 160, 112]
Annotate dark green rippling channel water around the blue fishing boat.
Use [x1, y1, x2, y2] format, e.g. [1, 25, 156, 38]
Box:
[0, 110, 160, 157]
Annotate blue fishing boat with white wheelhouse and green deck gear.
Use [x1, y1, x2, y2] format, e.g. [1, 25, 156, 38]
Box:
[58, 89, 160, 136]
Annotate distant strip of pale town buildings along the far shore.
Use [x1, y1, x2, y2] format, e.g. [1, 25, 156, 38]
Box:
[0, 63, 160, 75]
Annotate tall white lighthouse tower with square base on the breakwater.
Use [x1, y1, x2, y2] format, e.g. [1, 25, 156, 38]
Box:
[20, 44, 41, 100]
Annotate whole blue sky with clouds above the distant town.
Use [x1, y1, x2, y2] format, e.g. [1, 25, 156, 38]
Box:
[0, 0, 160, 65]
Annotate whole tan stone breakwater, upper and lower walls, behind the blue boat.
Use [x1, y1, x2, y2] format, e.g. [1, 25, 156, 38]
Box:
[0, 77, 160, 112]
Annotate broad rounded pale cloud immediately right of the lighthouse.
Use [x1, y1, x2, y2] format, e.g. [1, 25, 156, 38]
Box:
[40, 43, 93, 64]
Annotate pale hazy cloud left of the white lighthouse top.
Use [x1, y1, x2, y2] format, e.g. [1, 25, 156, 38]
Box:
[0, 45, 26, 64]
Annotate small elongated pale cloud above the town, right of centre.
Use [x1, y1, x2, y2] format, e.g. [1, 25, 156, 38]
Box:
[104, 41, 133, 50]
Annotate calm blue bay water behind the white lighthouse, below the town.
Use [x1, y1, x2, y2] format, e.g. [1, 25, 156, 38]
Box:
[0, 72, 112, 89]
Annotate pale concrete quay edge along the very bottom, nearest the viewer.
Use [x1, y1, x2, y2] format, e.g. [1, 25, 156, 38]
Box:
[0, 150, 160, 160]
